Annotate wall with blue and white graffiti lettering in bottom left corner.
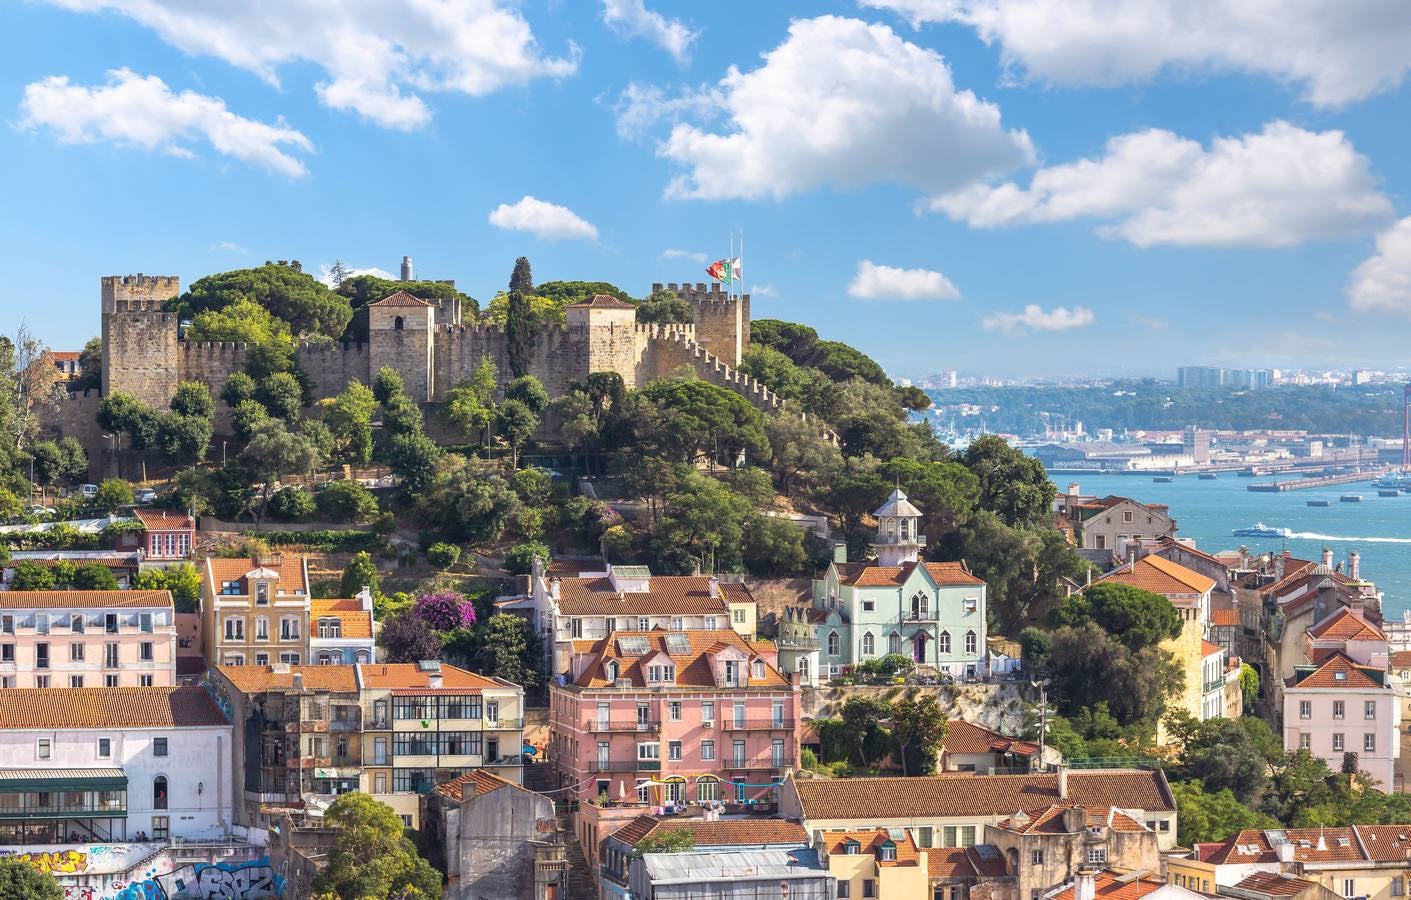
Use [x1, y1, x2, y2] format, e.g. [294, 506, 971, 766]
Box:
[63, 856, 284, 900]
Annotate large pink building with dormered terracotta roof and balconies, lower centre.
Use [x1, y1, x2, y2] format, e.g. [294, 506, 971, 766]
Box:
[549, 629, 800, 805]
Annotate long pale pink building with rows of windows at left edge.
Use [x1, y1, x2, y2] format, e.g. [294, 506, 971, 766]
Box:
[0, 591, 176, 687]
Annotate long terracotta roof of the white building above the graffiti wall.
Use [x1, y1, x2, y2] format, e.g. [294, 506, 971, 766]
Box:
[0, 687, 229, 728]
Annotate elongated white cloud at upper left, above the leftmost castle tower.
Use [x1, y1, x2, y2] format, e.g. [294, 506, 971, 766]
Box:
[20, 69, 313, 178]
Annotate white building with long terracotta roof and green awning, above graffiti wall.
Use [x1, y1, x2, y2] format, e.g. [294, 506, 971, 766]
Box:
[0, 687, 234, 852]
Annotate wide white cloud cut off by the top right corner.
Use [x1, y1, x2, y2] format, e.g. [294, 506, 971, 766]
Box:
[861, 0, 1411, 106]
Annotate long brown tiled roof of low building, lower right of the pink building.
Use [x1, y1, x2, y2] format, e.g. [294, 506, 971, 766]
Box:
[794, 769, 1175, 821]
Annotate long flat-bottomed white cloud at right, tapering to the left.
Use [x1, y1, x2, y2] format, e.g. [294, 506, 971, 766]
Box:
[931, 121, 1393, 247]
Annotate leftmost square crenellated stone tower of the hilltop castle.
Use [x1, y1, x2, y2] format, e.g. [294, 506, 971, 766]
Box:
[102, 274, 181, 409]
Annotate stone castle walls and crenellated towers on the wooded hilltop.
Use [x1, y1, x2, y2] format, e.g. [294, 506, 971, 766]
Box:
[102, 275, 801, 430]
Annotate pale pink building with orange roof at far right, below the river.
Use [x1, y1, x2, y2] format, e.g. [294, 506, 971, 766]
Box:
[1284, 650, 1401, 790]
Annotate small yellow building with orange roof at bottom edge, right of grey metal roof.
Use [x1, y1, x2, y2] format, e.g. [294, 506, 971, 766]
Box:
[818, 828, 931, 900]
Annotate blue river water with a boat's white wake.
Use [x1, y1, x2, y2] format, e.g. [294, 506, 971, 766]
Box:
[1050, 473, 1411, 618]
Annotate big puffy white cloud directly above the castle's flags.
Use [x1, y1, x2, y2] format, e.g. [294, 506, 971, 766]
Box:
[658, 16, 1033, 200]
